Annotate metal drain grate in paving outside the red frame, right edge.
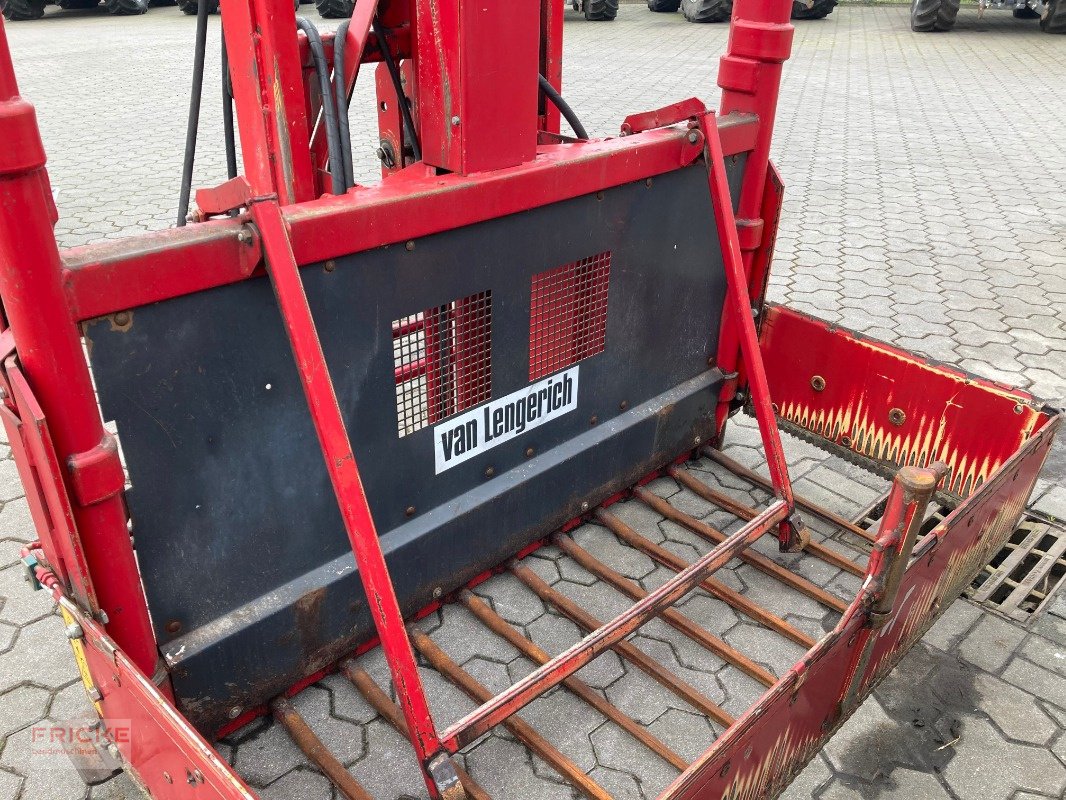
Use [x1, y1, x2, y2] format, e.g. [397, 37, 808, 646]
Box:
[967, 511, 1066, 622]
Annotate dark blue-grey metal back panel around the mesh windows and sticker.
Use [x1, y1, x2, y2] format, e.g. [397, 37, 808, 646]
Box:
[87, 163, 742, 729]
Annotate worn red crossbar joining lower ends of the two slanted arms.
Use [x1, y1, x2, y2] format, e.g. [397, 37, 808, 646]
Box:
[434, 500, 788, 752]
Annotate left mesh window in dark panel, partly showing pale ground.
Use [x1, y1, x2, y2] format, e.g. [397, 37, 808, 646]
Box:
[392, 291, 492, 436]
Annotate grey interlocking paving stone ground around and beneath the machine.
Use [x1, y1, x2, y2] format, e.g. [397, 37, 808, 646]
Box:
[0, 5, 1066, 800]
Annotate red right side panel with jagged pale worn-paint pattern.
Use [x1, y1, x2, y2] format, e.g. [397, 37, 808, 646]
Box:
[761, 306, 1046, 497]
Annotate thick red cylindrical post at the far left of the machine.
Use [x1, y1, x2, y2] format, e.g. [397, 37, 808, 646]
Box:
[0, 20, 158, 677]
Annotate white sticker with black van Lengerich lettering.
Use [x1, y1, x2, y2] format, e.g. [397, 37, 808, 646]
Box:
[433, 367, 579, 475]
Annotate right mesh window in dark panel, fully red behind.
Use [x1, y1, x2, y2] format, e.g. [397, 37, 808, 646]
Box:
[530, 251, 611, 381]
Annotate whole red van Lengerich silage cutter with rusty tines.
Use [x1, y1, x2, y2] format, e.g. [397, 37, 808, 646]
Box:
[0, 0, 1062, 800]
